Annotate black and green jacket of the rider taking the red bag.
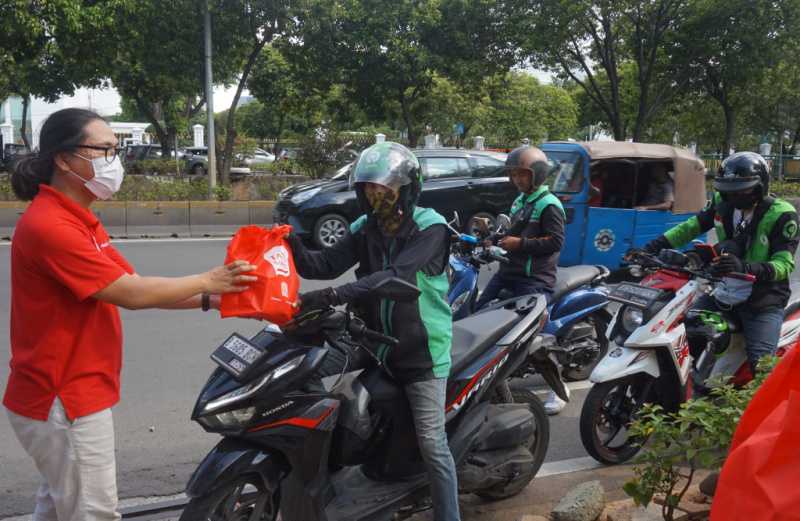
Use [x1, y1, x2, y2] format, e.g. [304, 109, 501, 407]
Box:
[294, 207, 453, 383]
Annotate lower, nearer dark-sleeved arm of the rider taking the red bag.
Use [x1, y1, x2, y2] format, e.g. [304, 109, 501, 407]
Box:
[336, 224, 450, 304]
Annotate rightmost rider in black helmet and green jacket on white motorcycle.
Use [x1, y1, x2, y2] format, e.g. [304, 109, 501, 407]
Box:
[643, 152, 798, 371]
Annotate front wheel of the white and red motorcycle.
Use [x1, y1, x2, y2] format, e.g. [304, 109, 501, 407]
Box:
[580, 377, 646, 465]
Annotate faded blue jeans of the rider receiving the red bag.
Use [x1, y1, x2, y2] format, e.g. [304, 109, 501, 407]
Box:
[405, 378, 461, 521]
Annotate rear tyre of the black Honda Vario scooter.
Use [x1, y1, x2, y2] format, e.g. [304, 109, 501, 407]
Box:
[475, 381, 550, 501]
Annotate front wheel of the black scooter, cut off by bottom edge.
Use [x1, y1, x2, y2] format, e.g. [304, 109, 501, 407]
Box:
[180, 476, 280, 521]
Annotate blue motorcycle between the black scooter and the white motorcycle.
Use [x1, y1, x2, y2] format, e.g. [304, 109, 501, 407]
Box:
[447, 215, 611, 381]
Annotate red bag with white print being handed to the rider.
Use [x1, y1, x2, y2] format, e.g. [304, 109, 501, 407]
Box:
[220, 225, 300, 326]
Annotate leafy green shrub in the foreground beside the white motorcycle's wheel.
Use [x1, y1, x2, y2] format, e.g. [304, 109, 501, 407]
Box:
[624, 357, 778, 521]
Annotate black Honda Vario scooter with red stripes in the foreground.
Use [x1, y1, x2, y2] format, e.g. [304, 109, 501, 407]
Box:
[180, 279, 549, 521]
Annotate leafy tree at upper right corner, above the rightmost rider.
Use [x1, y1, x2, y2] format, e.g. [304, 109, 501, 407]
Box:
[678, 0, 800, 154]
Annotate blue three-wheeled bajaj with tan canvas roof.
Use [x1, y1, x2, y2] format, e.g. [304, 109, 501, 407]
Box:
[541, 141, 706, 275]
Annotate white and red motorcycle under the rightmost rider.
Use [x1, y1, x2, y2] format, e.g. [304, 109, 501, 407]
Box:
[580, 245, 800, 464]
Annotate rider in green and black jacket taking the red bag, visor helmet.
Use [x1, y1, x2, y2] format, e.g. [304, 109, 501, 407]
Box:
[289, 142, 460, 521]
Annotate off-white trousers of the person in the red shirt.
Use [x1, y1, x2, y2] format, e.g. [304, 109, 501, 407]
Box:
[7, 398, 122, 521]
